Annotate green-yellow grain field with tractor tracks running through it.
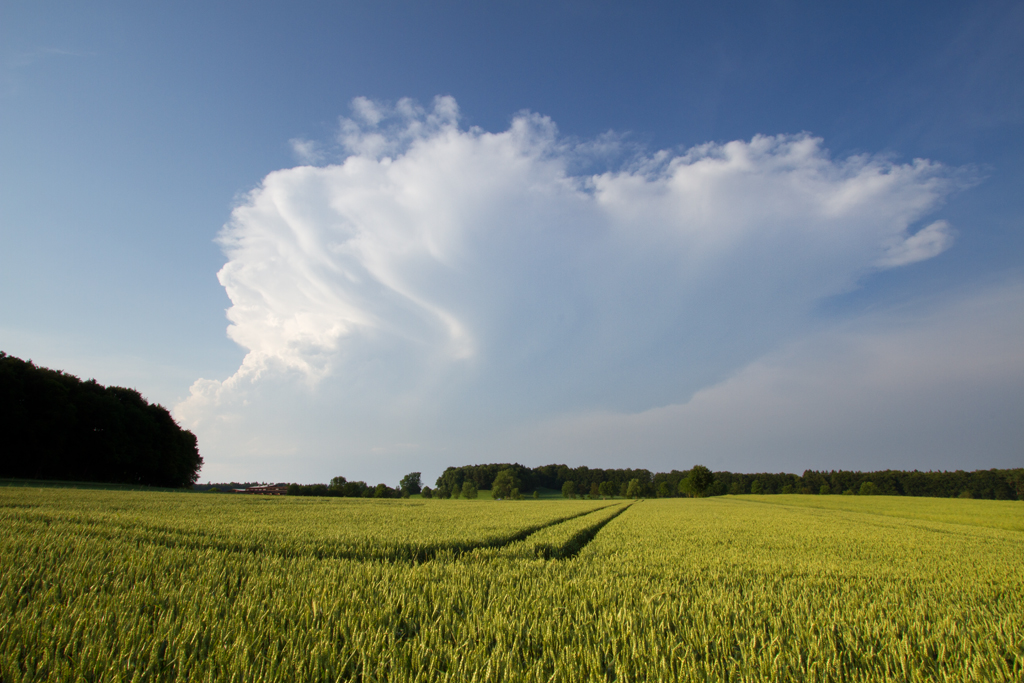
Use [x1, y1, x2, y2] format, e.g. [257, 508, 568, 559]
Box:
[0, 488, 1024, 683]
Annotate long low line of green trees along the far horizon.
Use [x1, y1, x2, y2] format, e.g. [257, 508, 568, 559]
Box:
[274, 463, 1024, 501]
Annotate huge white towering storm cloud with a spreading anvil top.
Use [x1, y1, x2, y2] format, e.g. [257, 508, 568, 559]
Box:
[176, 97, 958, 458]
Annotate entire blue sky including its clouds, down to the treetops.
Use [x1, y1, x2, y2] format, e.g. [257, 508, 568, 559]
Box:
[0, 2, 1024, 483]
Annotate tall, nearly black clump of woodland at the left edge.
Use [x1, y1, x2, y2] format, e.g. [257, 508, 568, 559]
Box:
[0, 351, 203, 488]
